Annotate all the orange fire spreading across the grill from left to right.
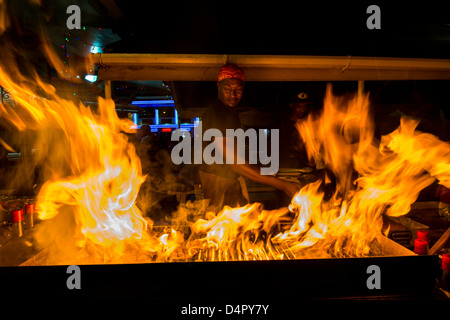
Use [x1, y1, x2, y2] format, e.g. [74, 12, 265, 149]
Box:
[0, 2, 450, 264]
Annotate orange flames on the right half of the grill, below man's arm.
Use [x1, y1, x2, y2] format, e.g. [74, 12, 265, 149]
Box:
[171, 86, 450, 260]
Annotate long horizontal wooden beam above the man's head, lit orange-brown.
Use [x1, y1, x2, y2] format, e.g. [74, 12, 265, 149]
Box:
[90, 53, 450, 81]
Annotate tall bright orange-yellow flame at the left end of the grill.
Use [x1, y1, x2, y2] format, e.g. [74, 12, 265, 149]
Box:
[0, 60, 151, 262]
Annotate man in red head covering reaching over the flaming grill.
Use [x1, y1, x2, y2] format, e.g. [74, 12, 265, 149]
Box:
[199, 64, 300, 209]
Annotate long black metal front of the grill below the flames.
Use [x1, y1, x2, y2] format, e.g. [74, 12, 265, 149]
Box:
[1, 238, 438, 302]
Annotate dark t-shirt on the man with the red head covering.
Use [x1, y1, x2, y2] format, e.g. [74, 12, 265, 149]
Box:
[201, 100, 241, 179]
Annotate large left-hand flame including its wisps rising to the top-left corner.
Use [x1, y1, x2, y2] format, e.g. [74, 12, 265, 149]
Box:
[0, 2, 151, 262]
